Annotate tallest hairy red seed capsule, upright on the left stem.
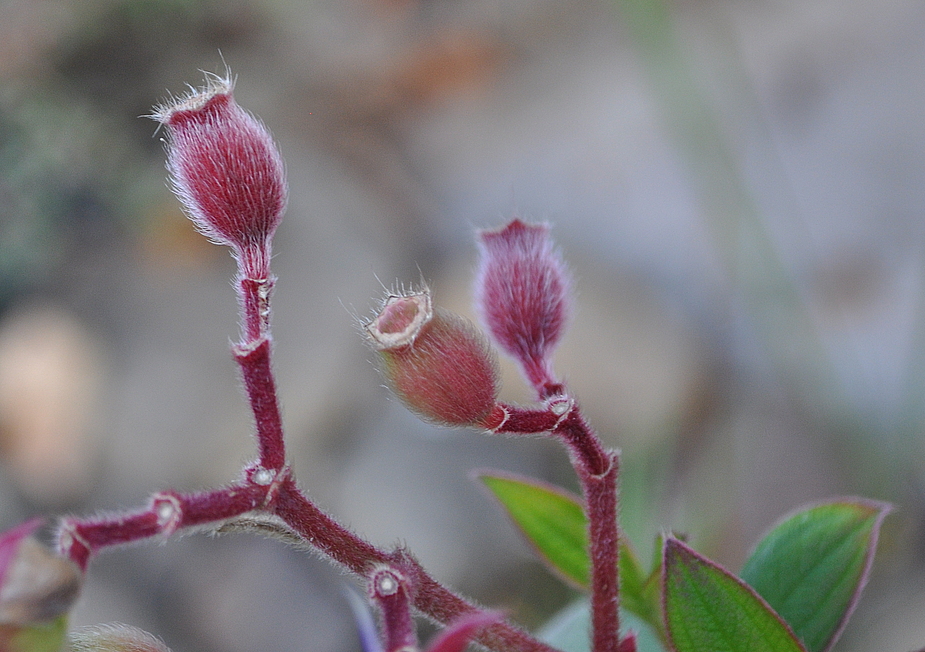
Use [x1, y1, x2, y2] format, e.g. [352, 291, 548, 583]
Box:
[152, 75, 286, 279]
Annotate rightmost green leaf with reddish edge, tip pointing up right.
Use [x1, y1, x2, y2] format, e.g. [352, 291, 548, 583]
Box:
[741, 499, 890, 652]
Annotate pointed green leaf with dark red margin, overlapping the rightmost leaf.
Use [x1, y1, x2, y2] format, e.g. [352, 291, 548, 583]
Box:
[663, 538, 806, 652]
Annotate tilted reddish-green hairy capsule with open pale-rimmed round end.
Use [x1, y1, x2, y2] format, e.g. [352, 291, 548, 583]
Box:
[366, 289, 498, 426]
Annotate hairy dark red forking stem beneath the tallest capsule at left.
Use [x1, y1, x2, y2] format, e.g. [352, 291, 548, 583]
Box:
[59, 246, 559, 652]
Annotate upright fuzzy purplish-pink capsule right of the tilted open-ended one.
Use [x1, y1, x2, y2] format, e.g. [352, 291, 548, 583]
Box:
[476, 219, 569, 388]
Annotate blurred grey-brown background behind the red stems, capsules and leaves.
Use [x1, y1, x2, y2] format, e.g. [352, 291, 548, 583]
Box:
[0, 0, 925, 652]
